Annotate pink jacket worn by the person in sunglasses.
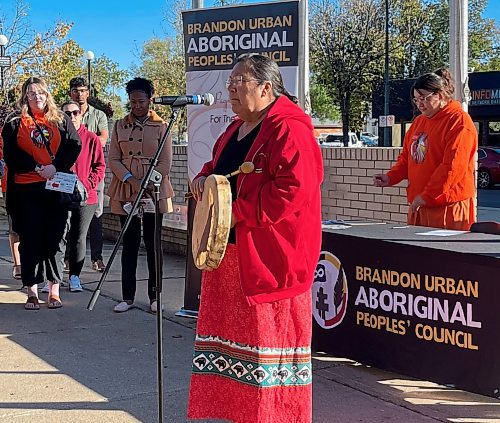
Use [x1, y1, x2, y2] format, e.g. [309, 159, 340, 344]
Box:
[73, 125, 106, 204]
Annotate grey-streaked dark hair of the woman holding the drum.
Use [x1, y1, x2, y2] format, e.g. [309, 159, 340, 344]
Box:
[236, 53, 299, 103]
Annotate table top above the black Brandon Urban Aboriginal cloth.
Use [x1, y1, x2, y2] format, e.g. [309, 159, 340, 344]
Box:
[323, 221, 500, 258]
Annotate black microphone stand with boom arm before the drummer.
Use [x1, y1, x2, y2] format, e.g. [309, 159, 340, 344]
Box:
[87, 107, 180, 423]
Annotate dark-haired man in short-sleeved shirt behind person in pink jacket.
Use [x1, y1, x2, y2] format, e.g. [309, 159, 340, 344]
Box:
[69, 77, 109, 272]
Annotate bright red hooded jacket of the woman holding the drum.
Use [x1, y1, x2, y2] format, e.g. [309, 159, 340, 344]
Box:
[197, 96, 323, 305]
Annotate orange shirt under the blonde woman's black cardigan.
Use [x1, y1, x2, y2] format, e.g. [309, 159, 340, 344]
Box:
[15, 116, 61, 184]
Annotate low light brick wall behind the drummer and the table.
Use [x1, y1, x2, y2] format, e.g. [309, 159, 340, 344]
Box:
[103, 146, 408, 254]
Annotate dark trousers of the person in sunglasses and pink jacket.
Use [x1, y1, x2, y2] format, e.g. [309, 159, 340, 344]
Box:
[66, 204, 97, 276]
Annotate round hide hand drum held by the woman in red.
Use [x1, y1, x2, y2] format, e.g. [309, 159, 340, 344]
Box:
[191, 175, 232, 270]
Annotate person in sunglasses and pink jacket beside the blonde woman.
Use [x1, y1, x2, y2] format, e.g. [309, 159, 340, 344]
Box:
[61, 100, 106, 292]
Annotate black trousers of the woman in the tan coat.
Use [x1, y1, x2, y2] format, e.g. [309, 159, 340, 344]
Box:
[120, 213, 161, 302]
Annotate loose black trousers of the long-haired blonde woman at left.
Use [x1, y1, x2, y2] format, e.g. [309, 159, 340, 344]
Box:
[12, 182, 68, 286]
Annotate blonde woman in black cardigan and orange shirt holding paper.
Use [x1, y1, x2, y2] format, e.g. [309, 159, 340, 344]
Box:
[2, 77, 81, 310]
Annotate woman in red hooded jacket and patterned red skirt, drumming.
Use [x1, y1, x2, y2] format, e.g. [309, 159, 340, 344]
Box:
[188, 54, 323, 423]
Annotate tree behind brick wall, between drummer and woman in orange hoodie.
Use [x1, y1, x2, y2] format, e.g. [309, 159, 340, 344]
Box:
[309, 0, 384, 146]
